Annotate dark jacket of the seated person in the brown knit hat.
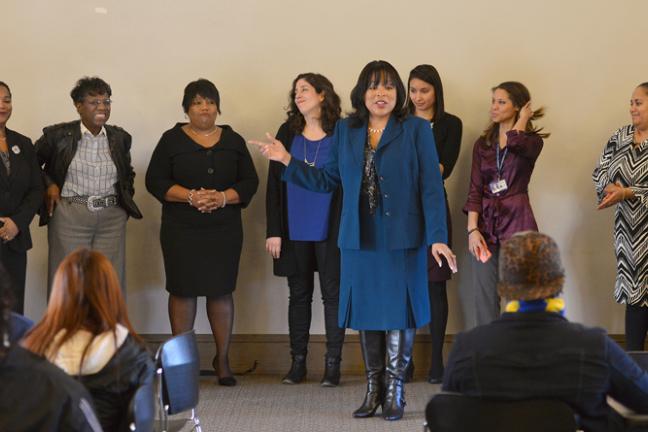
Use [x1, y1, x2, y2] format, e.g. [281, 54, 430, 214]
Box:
[443, 312, 648, 431]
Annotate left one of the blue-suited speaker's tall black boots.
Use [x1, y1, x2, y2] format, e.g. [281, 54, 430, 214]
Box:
[353, 330, 385, 418]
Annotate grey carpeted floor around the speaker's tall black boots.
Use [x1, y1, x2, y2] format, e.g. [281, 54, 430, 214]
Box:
[174, 375, 440, 432]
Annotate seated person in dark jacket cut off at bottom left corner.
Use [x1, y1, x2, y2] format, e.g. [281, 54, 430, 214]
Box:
[0, 265, 101, 432]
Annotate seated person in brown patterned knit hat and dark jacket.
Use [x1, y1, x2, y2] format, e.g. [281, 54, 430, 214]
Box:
[443, 231, 648, 431]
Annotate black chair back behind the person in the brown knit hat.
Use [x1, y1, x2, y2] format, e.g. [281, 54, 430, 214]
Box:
[425, 393, 577, 432]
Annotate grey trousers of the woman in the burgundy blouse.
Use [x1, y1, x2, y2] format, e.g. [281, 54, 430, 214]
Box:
[471, 249, 500, 326]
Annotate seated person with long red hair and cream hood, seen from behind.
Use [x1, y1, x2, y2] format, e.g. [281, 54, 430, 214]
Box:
[24, 249, 153, 431]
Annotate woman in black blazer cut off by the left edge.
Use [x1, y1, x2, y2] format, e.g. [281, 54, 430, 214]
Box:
[0, 81, 43, 314]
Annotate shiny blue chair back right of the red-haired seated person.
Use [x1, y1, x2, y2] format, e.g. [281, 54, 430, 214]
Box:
[155, 330, 200, 414]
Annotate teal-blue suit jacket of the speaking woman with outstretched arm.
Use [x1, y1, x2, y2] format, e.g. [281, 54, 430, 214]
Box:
[284, 116, 448, 250]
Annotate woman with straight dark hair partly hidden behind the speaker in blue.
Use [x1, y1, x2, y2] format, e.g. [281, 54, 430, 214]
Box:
[407, 64, 462, 384]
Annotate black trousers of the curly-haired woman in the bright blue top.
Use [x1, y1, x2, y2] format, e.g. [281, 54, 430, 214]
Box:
[288, 241, 344, 358]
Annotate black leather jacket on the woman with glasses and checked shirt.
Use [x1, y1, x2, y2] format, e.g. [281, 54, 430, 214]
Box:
[34, 120, 142, 225]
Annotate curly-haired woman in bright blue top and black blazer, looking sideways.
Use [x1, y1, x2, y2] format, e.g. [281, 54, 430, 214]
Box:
[266, 73, 344, 387]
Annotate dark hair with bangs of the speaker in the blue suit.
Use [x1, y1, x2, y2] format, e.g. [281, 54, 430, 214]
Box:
[349, 60, 409, 127]
